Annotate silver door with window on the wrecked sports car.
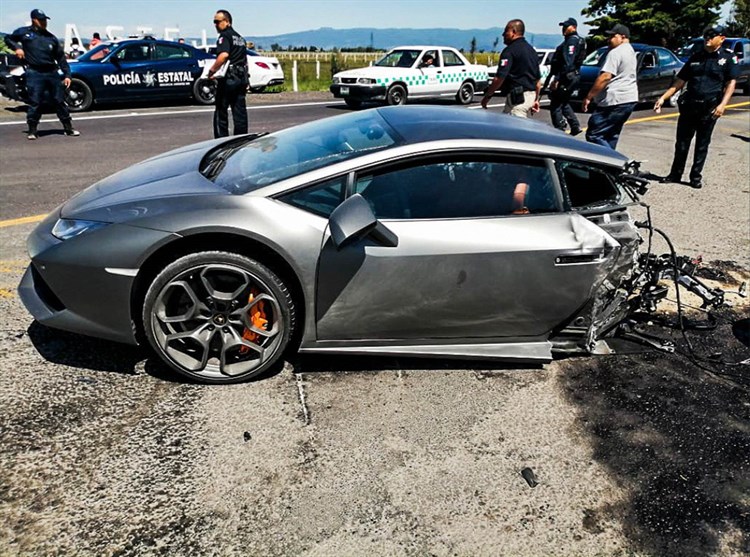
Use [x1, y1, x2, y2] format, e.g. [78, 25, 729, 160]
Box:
[315, 154, 618, 342]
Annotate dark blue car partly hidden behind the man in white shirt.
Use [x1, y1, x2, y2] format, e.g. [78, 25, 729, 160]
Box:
[571, 43, 683, 106]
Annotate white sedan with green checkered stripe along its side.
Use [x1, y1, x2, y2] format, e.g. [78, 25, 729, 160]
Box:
[330, 46, 489, 108]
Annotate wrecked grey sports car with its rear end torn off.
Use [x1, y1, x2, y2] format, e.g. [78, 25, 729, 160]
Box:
[18, 106, 656, 383]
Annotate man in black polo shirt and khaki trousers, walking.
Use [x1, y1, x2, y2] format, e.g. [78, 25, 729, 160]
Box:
[482, 19, 542, 118]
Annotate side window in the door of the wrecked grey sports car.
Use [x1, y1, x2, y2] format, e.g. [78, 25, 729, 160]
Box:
[354, 156, 558, 219]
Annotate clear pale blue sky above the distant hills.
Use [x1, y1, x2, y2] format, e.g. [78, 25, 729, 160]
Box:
[0, 0, 729, 37]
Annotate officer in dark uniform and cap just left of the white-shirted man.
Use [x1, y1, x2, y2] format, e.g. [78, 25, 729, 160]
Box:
[545, 17, 586, 135]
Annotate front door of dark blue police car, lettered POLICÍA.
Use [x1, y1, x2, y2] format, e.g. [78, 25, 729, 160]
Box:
[102, 41, 158, 100]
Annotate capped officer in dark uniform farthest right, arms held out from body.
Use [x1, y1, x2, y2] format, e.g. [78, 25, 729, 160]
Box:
[654, 25, 739, 189]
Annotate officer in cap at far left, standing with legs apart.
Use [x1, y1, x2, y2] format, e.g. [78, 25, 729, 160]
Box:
[5, 10, 80, 139]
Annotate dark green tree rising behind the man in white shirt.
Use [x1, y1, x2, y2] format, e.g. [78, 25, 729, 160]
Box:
[581, 0, 724, 48]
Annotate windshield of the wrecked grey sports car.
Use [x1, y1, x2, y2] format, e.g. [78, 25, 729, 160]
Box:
[206, 110, 401, 194]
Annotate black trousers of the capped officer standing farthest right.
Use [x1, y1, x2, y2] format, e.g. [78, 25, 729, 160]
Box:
[669, 102, 716, 182]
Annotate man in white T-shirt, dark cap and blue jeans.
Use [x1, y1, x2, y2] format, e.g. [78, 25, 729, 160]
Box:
[583, 23, 638, 149]
